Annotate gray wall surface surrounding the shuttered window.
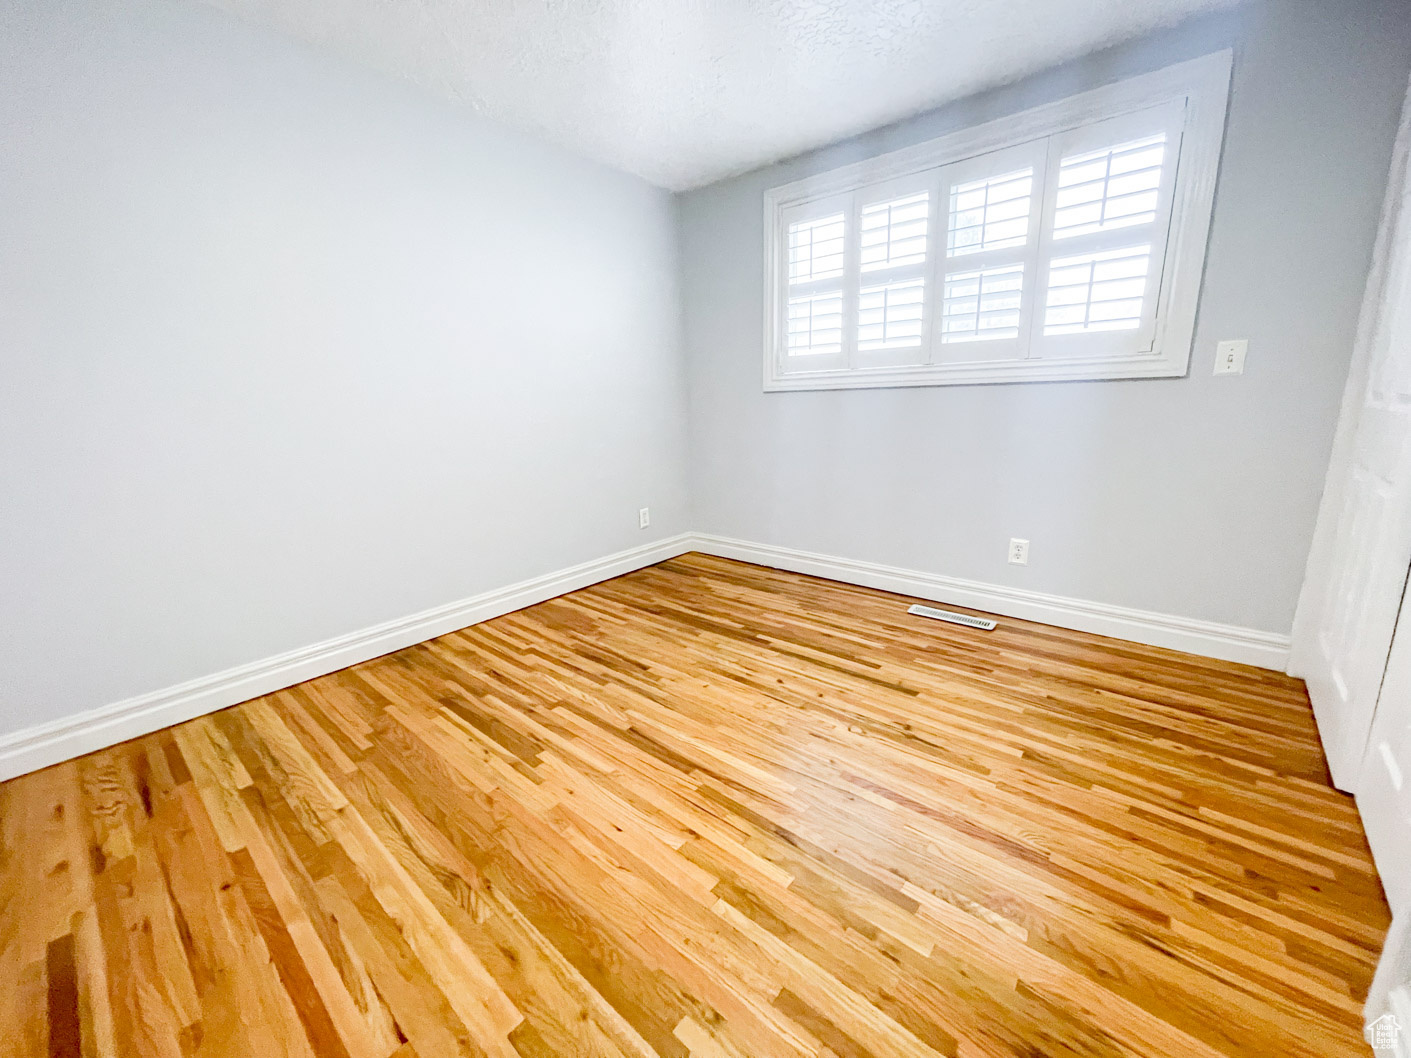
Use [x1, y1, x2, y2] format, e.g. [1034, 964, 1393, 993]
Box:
[680, 0, 1411, 632]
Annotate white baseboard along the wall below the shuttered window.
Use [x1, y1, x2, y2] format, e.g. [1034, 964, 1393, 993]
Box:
[691, 533, 1290, 671]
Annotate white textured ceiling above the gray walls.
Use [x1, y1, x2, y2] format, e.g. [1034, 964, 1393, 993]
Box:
[206, 0, 1233, 190]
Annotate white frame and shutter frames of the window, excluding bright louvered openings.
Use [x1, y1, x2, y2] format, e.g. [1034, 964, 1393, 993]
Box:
[763, 51, 1232, 391]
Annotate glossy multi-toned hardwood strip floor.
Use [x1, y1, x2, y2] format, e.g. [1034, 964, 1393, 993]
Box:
[0, 554, 1387, 1058]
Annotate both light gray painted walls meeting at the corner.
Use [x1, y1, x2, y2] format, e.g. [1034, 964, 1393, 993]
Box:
[0, 0, 1411, 732]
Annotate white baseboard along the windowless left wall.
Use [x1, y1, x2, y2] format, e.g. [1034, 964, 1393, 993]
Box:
[0, 533, 691, 780]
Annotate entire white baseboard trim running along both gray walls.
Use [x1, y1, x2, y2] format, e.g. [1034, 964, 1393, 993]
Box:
[0, 533, 1290, 780]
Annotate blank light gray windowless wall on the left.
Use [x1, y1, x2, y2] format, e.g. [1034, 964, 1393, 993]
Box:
[0, 0, 687, 732]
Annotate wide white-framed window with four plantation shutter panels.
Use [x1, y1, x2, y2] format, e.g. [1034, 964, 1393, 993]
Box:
[765, 52, 1230, 389]
